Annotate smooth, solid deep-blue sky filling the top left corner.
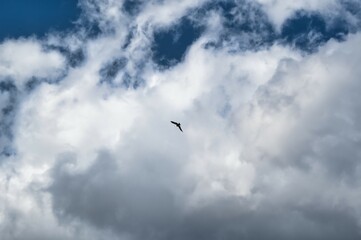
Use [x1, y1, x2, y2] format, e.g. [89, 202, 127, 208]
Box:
[0, 0, 81, 41]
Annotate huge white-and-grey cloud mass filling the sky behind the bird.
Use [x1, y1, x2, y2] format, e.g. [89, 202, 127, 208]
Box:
[0, 1, 361, 240]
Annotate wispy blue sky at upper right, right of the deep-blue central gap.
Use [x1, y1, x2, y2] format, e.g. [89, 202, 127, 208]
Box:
[207, 1, 350, 52]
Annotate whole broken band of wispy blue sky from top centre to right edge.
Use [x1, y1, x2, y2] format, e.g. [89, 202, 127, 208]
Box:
[152, 0, 361, 68]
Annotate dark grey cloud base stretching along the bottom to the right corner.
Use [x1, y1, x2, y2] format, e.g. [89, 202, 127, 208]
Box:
[49, 149, 359, 239]
